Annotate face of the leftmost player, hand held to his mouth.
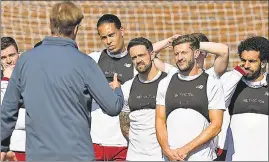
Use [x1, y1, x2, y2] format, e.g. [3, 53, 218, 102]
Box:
[1, 45, 19, 69]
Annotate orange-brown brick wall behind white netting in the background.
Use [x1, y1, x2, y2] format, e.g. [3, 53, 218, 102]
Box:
[1, 1, 268, 68]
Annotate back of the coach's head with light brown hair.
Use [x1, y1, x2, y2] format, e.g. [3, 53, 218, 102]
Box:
[50, 2, 84, 40]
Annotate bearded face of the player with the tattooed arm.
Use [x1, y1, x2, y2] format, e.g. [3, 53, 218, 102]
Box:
[129, 45, 152, 74]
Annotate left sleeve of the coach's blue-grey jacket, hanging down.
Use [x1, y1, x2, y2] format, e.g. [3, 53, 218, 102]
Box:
[1, 65, 21, 152]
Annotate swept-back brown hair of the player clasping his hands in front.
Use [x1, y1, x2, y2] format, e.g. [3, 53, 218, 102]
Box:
[172, 34, 200, 50]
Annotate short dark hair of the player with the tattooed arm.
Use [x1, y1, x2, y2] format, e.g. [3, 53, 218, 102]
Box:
[127, 37, 153, 53]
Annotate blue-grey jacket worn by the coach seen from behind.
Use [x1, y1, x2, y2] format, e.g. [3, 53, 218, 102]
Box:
[1, 37, 123, 161]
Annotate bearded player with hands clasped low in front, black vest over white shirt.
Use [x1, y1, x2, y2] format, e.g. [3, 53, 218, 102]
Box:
[155, 35, 225, 161]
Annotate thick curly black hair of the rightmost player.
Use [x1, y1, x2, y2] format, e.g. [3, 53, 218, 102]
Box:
[238, 36, 269, 62]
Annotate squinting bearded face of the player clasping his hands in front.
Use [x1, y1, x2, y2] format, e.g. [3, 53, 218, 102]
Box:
[174, 43, 194, 72]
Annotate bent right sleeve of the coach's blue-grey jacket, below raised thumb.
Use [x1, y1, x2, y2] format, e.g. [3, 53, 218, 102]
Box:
[86, 58, 124, 116]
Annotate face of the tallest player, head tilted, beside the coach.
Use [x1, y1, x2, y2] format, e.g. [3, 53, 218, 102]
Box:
[97, 23, 124, 54]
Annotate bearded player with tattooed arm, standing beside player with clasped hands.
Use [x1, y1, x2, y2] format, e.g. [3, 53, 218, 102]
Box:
[120, 37, 167, 161]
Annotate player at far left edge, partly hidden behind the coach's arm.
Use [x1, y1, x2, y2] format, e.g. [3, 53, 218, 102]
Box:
[1, 37, 26, 161]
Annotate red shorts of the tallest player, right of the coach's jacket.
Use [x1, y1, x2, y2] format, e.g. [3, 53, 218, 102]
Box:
[93, 144, 127, 161]
